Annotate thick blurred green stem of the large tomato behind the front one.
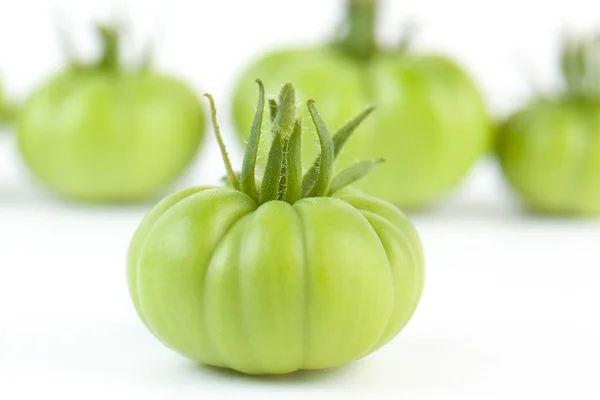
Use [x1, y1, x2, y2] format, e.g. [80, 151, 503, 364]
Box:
[341, 0, 377, 59]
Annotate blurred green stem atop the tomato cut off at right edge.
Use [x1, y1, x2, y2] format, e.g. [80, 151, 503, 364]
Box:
[560, 34, 600, 100]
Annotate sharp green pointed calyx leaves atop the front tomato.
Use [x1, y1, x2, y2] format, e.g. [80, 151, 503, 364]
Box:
[205, 80, 382, 204]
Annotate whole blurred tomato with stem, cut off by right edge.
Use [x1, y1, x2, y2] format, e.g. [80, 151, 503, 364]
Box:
[496, 35, 600, 217]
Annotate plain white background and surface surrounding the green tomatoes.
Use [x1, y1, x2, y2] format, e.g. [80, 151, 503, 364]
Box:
[0, 0, 600, 400]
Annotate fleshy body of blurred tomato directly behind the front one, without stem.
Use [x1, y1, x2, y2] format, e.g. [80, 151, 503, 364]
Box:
[233, 48, 490, 208]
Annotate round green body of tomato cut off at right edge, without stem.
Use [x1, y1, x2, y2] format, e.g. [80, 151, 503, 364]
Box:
[497, 99, 600, 215]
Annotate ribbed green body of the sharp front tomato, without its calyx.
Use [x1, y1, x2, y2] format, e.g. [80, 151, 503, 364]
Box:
[127, 188, 424, 374]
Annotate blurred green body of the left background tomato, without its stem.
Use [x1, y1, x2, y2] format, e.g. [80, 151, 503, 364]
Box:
[18, 71, 205, 202]
